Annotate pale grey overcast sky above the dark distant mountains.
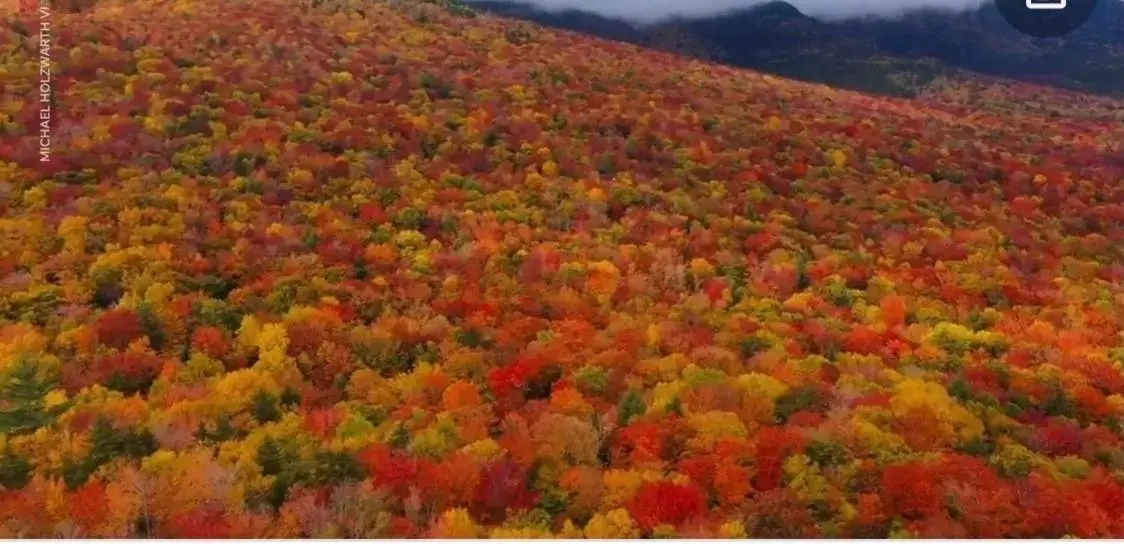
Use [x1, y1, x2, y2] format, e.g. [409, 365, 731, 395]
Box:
[478, 0, 986, 21]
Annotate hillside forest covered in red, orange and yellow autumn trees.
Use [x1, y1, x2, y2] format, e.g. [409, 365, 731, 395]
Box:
[0, 0, 1124, 539]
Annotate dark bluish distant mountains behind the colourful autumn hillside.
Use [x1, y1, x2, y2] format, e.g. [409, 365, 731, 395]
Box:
[472, 0, 1124, 96]
